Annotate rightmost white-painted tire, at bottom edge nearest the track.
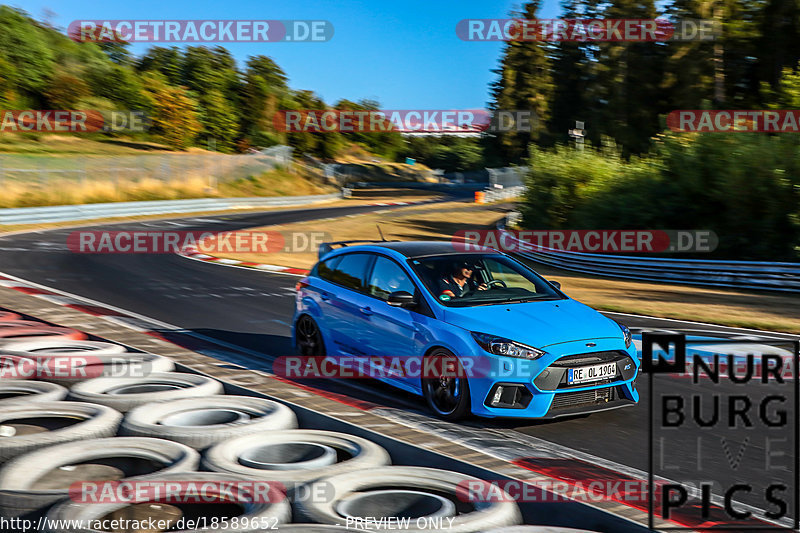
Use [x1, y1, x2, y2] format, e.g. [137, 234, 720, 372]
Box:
[297, 466, 522, 533]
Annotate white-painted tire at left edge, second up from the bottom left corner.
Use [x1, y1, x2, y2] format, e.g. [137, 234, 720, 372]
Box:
[0, 402, 122, 463]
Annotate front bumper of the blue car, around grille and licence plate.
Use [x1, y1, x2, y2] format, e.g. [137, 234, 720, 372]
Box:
[469, 339, 640, 418]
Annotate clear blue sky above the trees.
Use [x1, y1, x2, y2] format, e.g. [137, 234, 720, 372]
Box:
[12, 0, 559, 109]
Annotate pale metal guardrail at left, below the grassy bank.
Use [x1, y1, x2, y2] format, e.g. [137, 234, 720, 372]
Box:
[0, 193, 340, 226]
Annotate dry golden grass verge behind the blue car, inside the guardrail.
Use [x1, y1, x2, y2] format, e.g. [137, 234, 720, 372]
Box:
[217, 203, 800, 333]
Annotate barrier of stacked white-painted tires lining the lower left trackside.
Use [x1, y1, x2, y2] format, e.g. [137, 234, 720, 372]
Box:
[0, 311, 596, 533]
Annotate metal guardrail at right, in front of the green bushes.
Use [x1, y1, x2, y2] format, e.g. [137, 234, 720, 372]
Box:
[500, 230, 800, 292]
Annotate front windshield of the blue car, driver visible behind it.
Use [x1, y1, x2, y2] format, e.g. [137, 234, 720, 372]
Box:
[409, 254, 564, 307]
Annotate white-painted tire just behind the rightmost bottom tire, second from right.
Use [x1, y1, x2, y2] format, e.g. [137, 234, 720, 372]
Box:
[203, 429, 390, 489]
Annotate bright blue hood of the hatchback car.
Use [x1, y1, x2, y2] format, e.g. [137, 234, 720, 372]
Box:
[444, 299, 622, 348]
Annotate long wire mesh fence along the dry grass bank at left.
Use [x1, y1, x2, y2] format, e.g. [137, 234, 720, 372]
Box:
[0, 146, 291, 186]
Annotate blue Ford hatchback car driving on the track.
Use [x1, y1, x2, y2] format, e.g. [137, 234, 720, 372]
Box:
[292, 241, 640, 420]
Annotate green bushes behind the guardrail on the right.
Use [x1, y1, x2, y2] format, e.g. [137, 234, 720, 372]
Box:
[521, 133, 800, 261]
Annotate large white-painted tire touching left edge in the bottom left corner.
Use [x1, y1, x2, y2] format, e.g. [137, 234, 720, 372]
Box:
[0, 437, 200, 519]
